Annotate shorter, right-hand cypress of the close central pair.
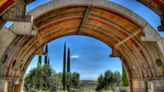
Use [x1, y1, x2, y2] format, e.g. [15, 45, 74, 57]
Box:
[67, 48, 71, 90]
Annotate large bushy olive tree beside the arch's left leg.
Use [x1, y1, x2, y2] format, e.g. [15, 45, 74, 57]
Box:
[25, 61, 54, 92]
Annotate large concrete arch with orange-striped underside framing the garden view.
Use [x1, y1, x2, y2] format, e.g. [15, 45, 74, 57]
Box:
[0, 0, 164, 92]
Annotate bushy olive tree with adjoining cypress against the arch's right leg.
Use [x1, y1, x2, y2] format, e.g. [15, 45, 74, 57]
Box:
[96, 65, 129, 91]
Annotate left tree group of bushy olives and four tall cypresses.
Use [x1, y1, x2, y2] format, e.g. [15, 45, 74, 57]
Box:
[24, 44, 80, 92]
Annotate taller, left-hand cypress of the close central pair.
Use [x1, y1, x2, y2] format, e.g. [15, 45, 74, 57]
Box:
[62, 43, 67, 90]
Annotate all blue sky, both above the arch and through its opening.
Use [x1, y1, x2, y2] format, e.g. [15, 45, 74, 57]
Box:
[18, 0, 163, 80]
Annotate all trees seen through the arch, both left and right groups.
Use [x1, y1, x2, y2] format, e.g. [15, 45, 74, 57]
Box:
[24, 43, 128, 92]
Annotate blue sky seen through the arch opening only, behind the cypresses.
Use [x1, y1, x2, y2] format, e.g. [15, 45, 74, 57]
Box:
[29, 36, 122, 80]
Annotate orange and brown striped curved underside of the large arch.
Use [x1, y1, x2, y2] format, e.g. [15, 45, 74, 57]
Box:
[0, 6, 164, 82]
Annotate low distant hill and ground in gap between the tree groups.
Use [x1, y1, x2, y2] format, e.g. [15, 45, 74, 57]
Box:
[80, 80, 97, 90]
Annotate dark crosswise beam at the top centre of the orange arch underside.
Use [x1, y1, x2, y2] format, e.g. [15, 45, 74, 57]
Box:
[77, 6, 92, 35]
